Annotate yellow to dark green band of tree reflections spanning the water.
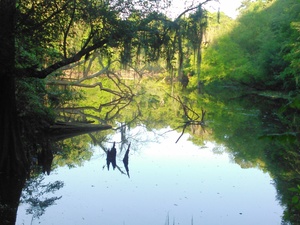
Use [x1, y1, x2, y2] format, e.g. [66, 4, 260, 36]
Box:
[15, 71, 300, 225]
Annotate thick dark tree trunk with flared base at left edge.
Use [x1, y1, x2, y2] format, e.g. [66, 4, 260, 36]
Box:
[0, 0, 28, 175]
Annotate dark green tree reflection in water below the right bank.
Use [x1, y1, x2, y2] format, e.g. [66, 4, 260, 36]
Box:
[210, 95, 300, 224]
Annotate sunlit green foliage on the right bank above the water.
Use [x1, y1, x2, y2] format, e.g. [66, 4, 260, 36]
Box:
[202, 0, 300, 91]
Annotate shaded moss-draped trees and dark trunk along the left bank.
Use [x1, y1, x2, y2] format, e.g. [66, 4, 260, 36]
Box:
[0, 0, 210, 174]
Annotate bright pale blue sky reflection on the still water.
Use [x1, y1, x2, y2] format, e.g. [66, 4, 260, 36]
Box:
[16, 127, 283, 225]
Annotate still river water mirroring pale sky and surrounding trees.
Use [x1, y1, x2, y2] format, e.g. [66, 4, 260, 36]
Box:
[16, 88, 289, 225]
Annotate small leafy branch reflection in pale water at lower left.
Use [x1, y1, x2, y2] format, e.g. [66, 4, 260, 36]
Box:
[20, 175, 64, 223]
